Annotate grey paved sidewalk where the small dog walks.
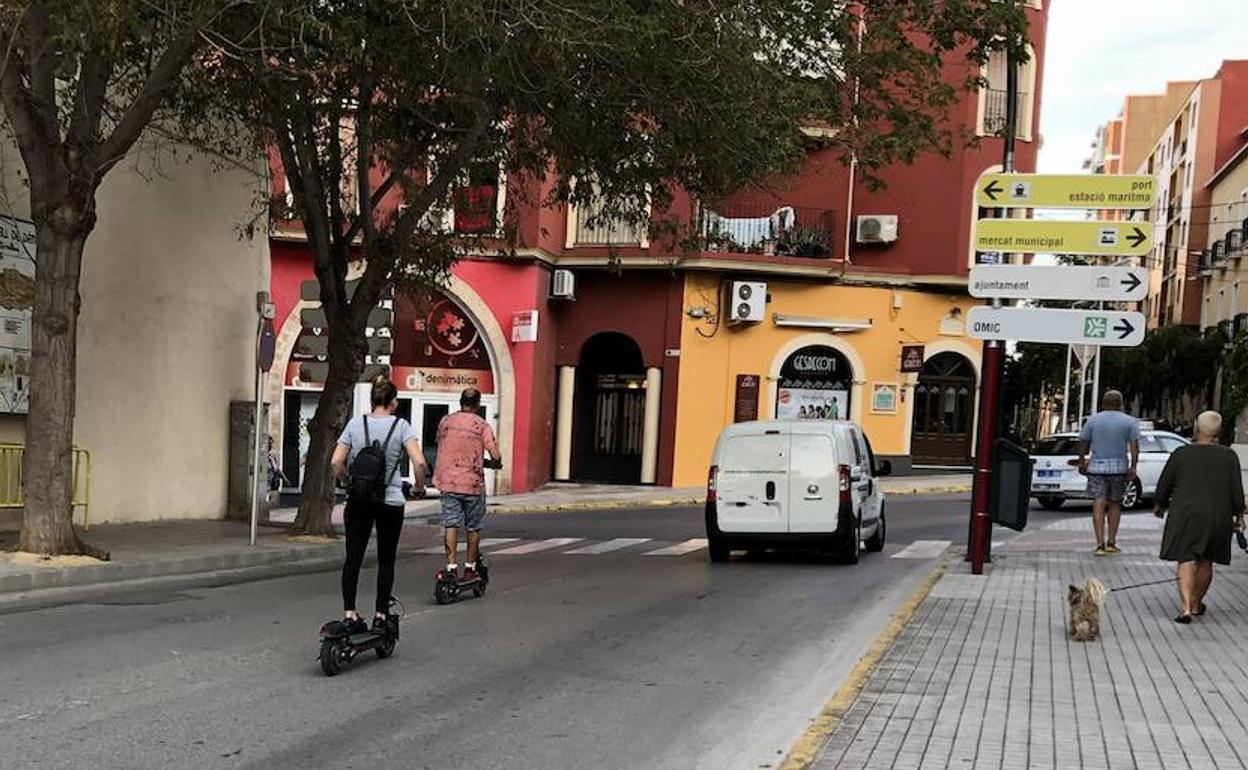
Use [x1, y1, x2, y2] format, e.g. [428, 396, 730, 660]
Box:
[811, 513, 1248, 770]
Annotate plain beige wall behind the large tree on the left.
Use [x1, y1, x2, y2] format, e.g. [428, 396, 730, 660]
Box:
[0, 144, 270, 523]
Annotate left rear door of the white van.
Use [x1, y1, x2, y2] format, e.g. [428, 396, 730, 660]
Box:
[715, 428, 789, 533]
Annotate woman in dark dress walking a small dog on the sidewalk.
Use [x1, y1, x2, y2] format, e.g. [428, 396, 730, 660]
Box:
[1154, 412, 1244, 623]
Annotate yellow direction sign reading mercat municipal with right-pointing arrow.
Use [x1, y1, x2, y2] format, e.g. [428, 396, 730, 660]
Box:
[975, 220, 1153, 257]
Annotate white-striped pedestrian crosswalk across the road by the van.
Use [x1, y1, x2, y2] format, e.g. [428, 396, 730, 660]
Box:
[414, 538, 952, 559]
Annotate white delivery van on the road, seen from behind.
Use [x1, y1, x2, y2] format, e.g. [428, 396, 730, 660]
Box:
[706, 419, 892, 563]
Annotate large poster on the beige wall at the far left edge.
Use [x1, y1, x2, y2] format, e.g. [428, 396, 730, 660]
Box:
[0, 216, 35, 414]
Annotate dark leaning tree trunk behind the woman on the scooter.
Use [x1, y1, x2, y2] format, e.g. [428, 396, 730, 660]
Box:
[293, 313, 367, 535]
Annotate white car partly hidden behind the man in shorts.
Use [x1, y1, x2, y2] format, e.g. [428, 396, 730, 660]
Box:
[1031, 431, 1188, 510]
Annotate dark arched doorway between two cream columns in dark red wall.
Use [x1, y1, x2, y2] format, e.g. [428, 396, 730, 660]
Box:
[572, 332, 645, 484]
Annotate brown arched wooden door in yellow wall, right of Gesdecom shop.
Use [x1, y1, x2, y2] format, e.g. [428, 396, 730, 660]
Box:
[910, 353, 975, 467]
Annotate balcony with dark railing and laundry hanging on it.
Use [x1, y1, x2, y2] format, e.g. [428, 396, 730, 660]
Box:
[695, 201, 836, 260]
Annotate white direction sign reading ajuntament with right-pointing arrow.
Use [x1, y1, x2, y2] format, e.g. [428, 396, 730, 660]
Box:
[970, 265, 1148, 302]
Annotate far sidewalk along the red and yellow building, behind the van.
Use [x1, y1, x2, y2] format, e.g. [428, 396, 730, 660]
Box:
[270, 473, 971, 524]
